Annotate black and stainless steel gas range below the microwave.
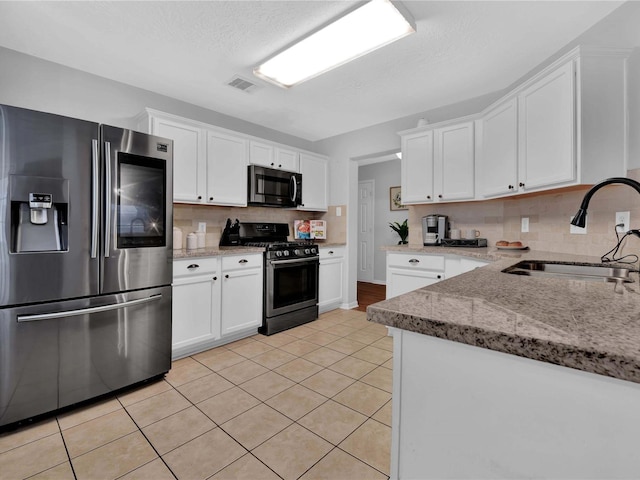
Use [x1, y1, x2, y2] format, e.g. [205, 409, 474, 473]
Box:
[221, 221, 320, 335]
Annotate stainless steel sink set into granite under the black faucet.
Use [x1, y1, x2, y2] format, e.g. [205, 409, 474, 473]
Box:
[502, 260, 634, 283]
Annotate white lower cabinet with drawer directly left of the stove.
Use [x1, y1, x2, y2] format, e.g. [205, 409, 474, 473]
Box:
[221, 254, 262, 337]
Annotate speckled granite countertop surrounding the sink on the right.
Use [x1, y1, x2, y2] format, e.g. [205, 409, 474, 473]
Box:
[367, 247, 640, 383]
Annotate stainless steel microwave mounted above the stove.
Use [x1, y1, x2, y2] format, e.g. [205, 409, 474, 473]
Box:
[247, 165, 302, 208]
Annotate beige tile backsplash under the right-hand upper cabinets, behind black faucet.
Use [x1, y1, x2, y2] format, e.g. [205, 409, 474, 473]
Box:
[409, 169, 640, 256]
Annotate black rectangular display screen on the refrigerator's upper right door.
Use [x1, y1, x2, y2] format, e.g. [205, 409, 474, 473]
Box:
[117, 152, 167, 248]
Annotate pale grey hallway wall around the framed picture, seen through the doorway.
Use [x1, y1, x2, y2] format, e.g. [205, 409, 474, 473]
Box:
[358, 160, 409, 283]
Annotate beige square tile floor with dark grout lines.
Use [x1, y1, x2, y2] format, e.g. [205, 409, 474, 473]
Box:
[0, 310, 393, 480]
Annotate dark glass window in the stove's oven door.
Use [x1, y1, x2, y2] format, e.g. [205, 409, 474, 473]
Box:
[272, 261, 318, 310]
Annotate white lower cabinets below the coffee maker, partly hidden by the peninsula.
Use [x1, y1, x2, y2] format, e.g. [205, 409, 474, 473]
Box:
[387, 252, 490, 298]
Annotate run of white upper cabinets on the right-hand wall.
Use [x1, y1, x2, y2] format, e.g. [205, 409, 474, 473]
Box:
[399, 47, 631, 204]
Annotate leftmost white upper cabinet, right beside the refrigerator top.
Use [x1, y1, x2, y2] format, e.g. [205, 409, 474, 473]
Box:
[140, 110, 207, 203]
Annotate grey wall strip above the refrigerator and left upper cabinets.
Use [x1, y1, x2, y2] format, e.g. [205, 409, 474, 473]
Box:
[0, 47, 314, 151]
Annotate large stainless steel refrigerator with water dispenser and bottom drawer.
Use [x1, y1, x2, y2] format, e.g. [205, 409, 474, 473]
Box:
[0, 105, 173, 426]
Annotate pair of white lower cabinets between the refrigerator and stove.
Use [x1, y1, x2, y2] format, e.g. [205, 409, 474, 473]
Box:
[172, 253, 263, 359]
